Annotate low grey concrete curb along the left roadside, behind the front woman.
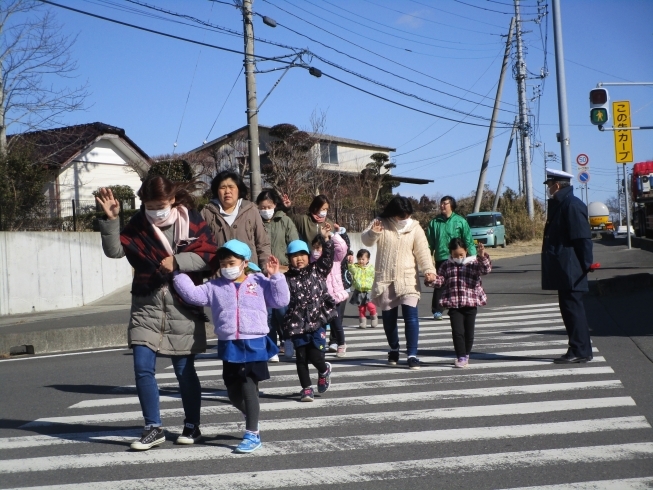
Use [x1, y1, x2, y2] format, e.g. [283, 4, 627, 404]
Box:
[0, 323, 215, 357]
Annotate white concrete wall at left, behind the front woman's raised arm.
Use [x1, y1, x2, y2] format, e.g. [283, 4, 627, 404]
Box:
[0, 232, 132, 315]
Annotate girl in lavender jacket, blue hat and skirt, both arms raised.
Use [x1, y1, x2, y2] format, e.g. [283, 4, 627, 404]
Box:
[174, 240, 290, 453]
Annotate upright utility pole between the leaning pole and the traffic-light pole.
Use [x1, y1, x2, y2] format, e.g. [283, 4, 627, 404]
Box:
[515, 0, 535, 219]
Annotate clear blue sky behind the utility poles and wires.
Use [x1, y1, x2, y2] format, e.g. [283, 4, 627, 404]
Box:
[10, 0, 653, 206]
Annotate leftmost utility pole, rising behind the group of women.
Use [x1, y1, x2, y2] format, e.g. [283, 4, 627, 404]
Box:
[243, 0, 261, 201]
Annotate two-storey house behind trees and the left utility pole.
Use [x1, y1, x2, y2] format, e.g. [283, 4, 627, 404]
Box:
[189, 125, 432, 184]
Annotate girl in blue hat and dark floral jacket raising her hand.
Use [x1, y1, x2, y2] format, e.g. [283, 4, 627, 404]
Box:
[283, 223, 337, 402]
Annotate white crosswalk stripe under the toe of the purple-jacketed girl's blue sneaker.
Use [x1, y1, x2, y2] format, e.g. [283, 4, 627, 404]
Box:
[0, 416, 651, 474]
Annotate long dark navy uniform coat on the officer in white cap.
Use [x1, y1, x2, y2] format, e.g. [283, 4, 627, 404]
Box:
[542, 186, 592, 291]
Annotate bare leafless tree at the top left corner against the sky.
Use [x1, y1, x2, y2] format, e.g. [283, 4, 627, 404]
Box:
[0, 0, 88, 155]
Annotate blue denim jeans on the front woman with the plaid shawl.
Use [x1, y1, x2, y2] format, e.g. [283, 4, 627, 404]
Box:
[132, 345, 202, 427]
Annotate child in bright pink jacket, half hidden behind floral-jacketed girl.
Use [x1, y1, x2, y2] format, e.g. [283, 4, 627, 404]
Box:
[311, 225, 349, 357]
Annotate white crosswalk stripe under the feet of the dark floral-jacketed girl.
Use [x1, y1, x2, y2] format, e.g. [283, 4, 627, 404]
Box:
[68, 366, 614, 408]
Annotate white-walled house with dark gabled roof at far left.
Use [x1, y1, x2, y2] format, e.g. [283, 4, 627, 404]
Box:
[9, 122, 150, 207]
